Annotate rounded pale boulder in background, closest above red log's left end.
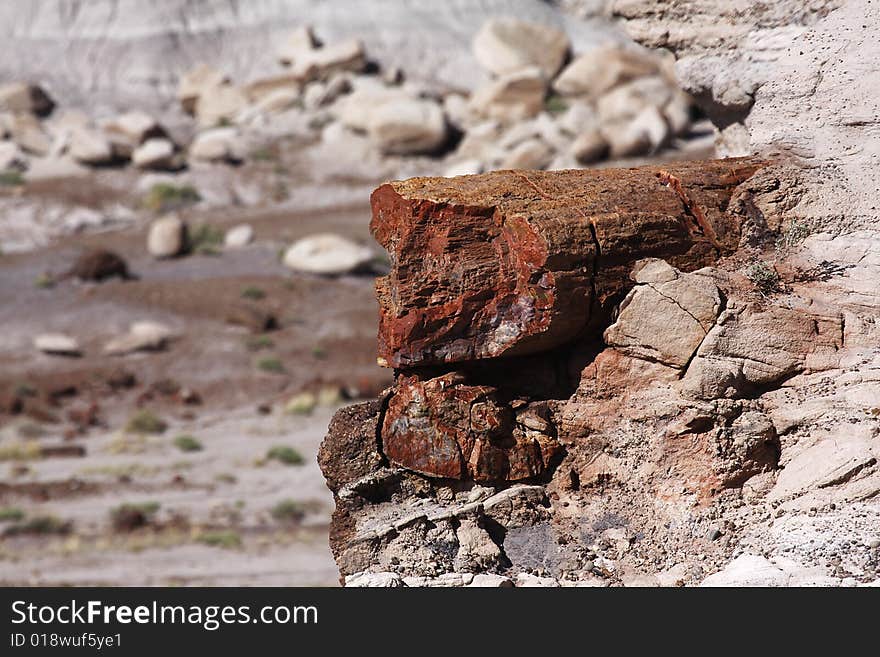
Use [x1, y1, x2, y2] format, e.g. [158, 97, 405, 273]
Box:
[367, 98, 446, 155]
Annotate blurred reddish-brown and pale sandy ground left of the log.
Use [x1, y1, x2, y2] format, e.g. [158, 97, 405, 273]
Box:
[0, 159, 390, 586]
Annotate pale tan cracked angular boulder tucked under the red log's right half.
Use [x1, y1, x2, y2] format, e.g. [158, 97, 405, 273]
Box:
[604, 261, 721, 368]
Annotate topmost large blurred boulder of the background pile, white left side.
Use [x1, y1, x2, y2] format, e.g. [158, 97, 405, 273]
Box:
[473, 17, 570, 79]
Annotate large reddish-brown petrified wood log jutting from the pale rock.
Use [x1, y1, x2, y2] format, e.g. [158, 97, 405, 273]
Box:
[371, 159, 761, 368]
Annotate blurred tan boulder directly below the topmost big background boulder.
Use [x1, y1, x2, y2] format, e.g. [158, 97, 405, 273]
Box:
[470, 66, 547, 123]
